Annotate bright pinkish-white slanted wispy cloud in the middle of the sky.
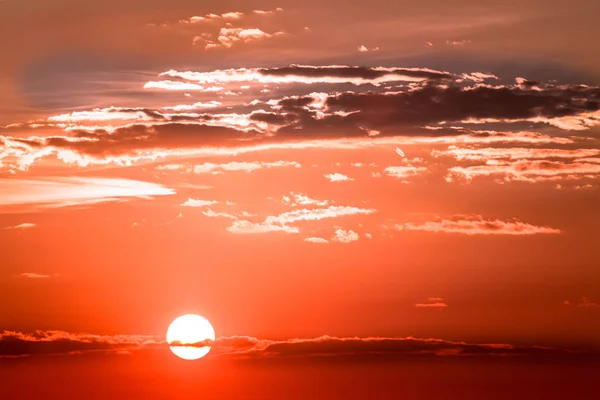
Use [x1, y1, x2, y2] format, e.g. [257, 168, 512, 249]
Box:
[227, 206, 375, 234]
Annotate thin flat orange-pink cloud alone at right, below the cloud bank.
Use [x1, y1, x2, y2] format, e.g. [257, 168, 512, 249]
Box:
[396, 215, 561, 236]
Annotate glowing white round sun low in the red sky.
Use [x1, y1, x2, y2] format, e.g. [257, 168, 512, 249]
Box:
[167, 314, 215, 360]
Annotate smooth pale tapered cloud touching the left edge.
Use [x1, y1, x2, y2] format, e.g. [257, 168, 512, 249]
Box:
[0, 177, 175, 207]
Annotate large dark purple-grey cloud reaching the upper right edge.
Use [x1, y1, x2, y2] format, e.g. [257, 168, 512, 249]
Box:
[327, 85, 600, 128]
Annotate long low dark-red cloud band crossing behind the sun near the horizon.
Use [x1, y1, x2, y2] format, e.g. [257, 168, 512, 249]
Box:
[0, 331, 580, 360]
